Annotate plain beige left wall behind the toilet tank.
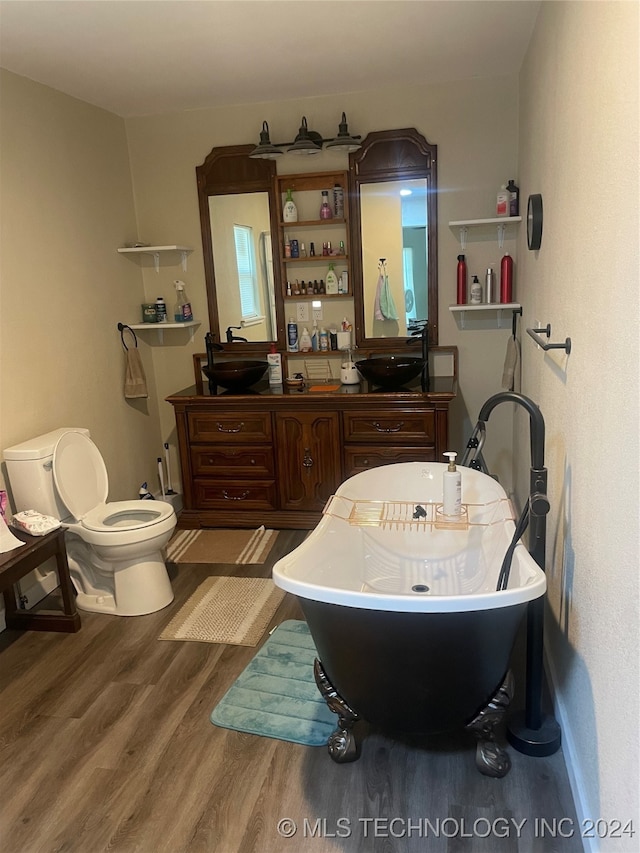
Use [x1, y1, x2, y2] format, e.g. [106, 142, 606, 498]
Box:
[0, 71, 161, 500]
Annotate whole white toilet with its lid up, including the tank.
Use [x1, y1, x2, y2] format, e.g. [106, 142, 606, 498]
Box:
[4, 428, 176, 616]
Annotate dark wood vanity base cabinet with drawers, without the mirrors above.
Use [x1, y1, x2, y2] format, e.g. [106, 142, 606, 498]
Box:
[167, 348, 457, 529]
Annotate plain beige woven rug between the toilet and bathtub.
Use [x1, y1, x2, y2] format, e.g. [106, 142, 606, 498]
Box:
[158, 577, 284, 646]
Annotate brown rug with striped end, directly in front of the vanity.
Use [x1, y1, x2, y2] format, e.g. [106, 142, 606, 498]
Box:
[167, 526, 278, 565]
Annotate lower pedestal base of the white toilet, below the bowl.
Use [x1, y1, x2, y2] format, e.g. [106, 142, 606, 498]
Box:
[67, 534, 173, 616]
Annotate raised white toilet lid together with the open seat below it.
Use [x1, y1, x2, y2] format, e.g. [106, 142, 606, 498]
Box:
[53, 432, 174, 533]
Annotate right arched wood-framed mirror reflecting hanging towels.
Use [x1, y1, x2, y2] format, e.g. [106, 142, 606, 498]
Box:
[349, 128, 438, 349]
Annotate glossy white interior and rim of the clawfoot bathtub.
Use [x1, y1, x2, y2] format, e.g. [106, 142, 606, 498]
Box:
[274, 463, 546, 611]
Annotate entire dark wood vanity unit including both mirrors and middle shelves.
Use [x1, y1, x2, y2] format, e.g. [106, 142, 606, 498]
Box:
[174, 128, 444, 529]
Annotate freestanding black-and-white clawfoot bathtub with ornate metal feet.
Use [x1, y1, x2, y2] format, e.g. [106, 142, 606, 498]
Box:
[273, 462, 546, 776]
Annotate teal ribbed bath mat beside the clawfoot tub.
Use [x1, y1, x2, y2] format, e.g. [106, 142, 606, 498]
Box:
[210, 620, 337, 746]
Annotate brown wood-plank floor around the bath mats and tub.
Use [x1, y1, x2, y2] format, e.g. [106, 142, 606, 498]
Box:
[0, 531, 582, 853]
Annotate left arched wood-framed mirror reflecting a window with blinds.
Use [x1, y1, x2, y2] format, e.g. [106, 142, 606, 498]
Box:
[196, 145, 284, 351]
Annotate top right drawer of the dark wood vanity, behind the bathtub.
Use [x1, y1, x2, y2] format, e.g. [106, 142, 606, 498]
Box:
[343, 411, 436, 446]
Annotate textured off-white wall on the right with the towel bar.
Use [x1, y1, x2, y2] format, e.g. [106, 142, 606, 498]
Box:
[518, 3, 640, 853]
